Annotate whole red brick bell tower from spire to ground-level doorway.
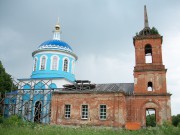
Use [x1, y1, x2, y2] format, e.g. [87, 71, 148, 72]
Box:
[126, 6, 171, 127]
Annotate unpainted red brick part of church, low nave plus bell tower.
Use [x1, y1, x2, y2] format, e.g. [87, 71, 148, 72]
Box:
[51, 7, 171, 127]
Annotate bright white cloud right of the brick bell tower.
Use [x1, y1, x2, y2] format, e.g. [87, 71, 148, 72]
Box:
[163, 31, 180, 114]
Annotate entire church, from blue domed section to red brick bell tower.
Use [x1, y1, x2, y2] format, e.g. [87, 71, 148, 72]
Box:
[3, 7, 171, 127]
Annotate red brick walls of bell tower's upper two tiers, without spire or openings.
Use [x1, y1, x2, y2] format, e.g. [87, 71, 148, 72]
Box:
[134, 35, 167, 94]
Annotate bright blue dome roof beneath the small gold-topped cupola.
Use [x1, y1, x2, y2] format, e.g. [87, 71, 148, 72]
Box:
[38, 40, 72, 52]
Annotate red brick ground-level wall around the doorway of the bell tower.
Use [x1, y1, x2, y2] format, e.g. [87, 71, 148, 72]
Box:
[126, 95, 171, 126]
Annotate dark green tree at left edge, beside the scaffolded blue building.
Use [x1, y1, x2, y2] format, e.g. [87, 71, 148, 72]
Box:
[0, 61, 16, 95]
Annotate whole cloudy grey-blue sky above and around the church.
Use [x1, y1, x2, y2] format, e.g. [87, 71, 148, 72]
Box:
[0, 0, 180, 115]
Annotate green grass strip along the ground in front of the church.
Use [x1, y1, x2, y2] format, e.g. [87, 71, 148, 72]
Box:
[0, 117, 180, 135]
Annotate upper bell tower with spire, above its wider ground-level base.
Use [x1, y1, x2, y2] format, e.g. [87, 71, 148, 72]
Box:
[133, 6, 167, 94]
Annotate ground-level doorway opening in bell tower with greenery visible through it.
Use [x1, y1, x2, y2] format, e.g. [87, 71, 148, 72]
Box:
[146, 108, 156, 127]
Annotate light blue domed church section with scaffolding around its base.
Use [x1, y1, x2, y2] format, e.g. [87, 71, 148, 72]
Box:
[6, 21, 77, 123]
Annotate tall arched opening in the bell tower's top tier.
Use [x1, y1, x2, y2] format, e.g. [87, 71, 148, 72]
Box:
[145, 44, 152, 63]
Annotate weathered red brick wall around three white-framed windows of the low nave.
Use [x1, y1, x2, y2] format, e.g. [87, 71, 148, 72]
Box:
[51, 93, 126, 127]
